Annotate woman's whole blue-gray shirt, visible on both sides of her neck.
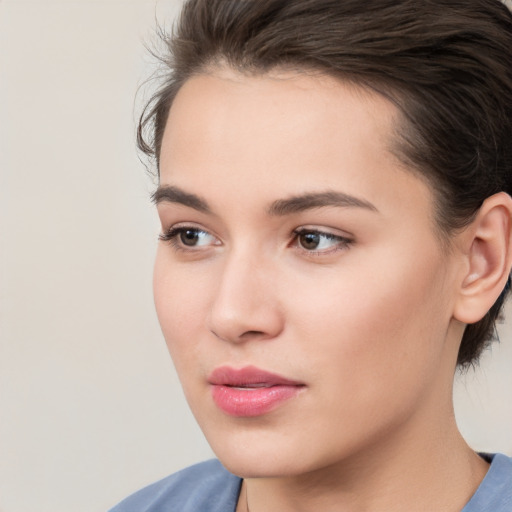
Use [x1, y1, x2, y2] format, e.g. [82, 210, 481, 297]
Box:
[110, 454, 512, 512]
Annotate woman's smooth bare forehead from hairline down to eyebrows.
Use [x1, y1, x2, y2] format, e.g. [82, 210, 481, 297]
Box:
[160, 68, 430, 226]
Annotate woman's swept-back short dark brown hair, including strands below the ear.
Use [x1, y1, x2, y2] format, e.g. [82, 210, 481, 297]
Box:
[138, 0, 512, 366]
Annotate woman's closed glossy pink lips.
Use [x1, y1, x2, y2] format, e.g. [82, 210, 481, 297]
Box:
[208, 366, 304, 417]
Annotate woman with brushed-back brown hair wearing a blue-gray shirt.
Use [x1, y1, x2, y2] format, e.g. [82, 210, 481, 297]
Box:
[110, 0, 512, 512]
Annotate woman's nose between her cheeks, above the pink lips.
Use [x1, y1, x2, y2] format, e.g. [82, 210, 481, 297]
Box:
[209, 250, 284, 343]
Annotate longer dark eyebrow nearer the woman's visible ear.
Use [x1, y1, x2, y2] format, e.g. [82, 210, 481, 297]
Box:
[268, 191, 378, 216]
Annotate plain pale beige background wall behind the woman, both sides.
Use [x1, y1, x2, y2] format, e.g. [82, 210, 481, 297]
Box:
[0, 0, 512, 512]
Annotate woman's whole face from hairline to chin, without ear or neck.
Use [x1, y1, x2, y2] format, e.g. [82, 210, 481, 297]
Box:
[154, 70, 464, 476]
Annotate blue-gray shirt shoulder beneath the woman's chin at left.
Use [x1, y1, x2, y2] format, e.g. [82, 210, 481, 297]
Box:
[110, 459, 241, 512]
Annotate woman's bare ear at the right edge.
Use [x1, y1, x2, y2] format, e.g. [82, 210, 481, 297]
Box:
[453, 192, 512, 324]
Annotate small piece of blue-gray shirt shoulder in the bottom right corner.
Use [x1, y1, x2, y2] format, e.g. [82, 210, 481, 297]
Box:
[462, 453, 512, 512]
